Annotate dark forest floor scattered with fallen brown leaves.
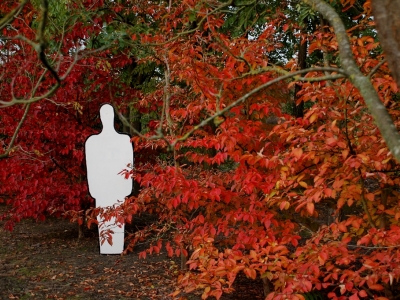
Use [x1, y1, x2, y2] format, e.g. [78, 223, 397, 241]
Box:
[0, 205, 263, 300]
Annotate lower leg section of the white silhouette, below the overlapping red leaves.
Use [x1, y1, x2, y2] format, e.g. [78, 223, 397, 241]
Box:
[97, 217, 125, 254]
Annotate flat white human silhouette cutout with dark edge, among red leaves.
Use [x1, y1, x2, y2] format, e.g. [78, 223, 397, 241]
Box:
[85, 104, 133, 254]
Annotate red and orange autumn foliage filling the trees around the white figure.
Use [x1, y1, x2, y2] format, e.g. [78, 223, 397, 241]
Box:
[0, 0, 400, 299]
